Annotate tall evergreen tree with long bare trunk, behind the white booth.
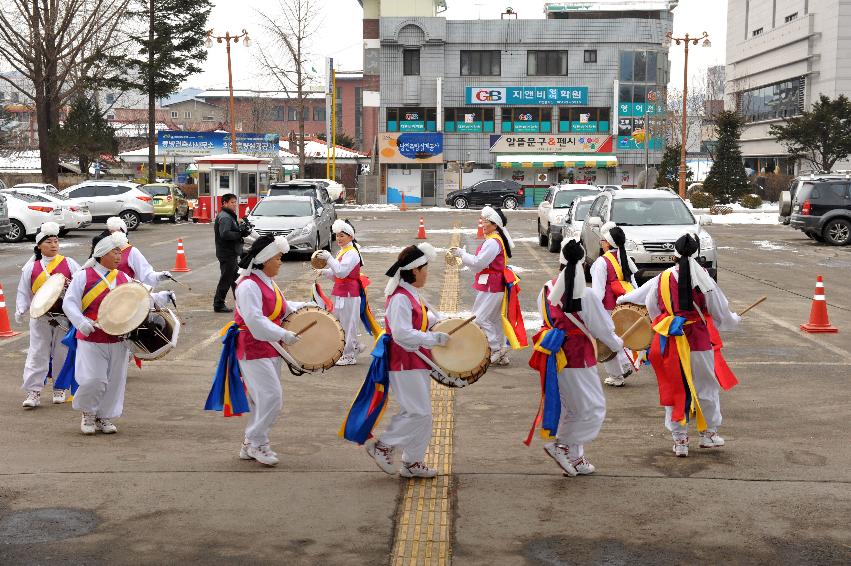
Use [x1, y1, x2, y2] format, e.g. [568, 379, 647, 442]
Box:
[112, 0, 212, 183]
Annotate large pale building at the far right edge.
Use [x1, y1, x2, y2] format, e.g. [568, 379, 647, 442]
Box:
[726, 0, 851, 174]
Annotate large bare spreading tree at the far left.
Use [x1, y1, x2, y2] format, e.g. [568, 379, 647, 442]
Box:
[0, 0, 129, 185]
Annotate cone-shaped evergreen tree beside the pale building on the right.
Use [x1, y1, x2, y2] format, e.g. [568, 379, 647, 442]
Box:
[703, 110, 749, 204]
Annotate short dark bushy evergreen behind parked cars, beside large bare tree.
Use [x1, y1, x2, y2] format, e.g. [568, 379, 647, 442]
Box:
[57, 95, 118, 177]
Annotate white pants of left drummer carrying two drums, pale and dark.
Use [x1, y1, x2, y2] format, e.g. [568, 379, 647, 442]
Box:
[72, 340, 130, 419]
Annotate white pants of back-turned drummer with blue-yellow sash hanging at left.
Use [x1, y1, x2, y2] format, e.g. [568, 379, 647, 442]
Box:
[557, 367, 606, 459]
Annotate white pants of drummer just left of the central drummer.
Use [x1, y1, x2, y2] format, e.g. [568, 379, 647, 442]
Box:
[239, 357, 284, 448]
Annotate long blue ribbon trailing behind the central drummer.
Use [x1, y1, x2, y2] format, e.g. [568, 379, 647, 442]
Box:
[343, 334, 391, 444]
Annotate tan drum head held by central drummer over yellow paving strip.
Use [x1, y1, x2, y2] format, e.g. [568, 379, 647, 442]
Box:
[431, 318, 491, 385]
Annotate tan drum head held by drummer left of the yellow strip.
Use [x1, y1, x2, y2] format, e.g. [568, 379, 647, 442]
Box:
[282, 307, 346, 371]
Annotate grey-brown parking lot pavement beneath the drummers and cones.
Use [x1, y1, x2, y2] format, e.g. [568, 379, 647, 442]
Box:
[0, 215, 851, 564]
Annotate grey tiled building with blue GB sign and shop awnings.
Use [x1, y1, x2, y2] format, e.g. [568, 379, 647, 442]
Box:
[378, 0, 676, 205]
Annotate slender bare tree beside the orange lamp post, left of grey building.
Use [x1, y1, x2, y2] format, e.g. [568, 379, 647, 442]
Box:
[258, 0, 320, 177]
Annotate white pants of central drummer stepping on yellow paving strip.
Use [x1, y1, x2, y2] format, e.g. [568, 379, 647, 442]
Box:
[379, 369, 431, 464]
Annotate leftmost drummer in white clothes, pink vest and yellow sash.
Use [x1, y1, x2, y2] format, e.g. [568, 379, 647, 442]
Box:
[15, 222, 80, 409]
